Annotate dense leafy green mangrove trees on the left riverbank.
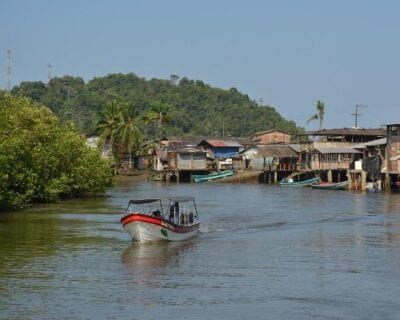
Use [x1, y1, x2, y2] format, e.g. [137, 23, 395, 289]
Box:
[0, 92, 111, 210]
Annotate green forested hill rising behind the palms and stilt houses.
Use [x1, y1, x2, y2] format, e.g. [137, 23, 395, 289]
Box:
[12, 73, 296, 137]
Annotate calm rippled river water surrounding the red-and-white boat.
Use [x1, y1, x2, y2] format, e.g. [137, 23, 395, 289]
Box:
[0, 179, 400, 319]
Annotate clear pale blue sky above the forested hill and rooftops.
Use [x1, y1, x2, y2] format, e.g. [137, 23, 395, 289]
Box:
[0, 0, 400, 130]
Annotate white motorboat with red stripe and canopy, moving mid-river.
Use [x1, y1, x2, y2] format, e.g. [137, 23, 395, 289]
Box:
[121, 197, 200, 242]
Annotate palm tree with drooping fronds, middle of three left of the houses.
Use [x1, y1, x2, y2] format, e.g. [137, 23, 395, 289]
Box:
[116, 104, 143, 168]
